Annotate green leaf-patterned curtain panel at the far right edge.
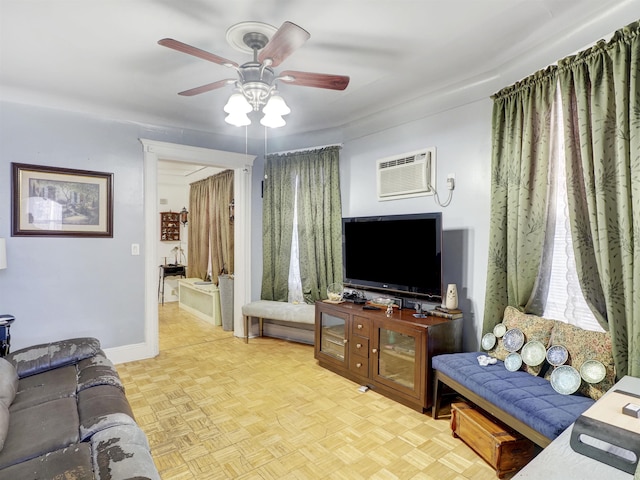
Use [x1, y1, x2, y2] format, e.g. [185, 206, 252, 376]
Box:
[558, 22, 640, 377]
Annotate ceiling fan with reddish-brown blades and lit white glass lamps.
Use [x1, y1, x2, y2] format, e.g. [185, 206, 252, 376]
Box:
[158, 22, 349, 127]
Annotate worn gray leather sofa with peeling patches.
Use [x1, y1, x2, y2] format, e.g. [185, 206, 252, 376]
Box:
[0, 338, 160, 480]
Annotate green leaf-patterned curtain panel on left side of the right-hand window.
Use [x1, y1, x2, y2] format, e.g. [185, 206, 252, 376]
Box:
[483, 67, 557, 332]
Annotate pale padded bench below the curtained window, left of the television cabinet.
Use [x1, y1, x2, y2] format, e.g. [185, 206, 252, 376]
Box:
[242, 300, 316, 343]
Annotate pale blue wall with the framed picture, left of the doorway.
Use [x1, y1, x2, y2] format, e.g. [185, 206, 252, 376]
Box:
[0, 102, 250, 350]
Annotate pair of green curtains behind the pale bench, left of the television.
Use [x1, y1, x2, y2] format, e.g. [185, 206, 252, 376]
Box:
[261, 146, 342, 303]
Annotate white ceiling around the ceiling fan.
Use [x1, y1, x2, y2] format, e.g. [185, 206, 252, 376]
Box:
[0, 0, 640, 141]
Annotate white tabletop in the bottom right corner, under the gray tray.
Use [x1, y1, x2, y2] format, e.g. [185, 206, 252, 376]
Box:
[513, 376, 640, 480]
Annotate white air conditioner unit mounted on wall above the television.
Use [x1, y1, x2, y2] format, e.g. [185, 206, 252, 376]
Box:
[376, 147, 436, 201]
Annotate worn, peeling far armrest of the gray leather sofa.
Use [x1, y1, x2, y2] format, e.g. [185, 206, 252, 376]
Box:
[4, 337, 100, 378]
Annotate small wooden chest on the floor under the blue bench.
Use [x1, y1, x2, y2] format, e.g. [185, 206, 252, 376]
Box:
[451, 402, 535, 478]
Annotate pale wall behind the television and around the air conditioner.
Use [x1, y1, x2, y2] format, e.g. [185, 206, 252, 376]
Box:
[252, 98, 492, 350]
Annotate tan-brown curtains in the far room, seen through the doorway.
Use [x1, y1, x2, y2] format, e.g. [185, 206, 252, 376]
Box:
[188, 170, 234, 283]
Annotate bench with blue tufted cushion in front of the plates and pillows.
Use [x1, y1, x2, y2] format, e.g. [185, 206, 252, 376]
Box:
[432, 352, 594, 448]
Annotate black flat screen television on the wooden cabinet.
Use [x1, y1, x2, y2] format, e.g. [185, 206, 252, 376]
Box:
[342, 212, 442, 302]
